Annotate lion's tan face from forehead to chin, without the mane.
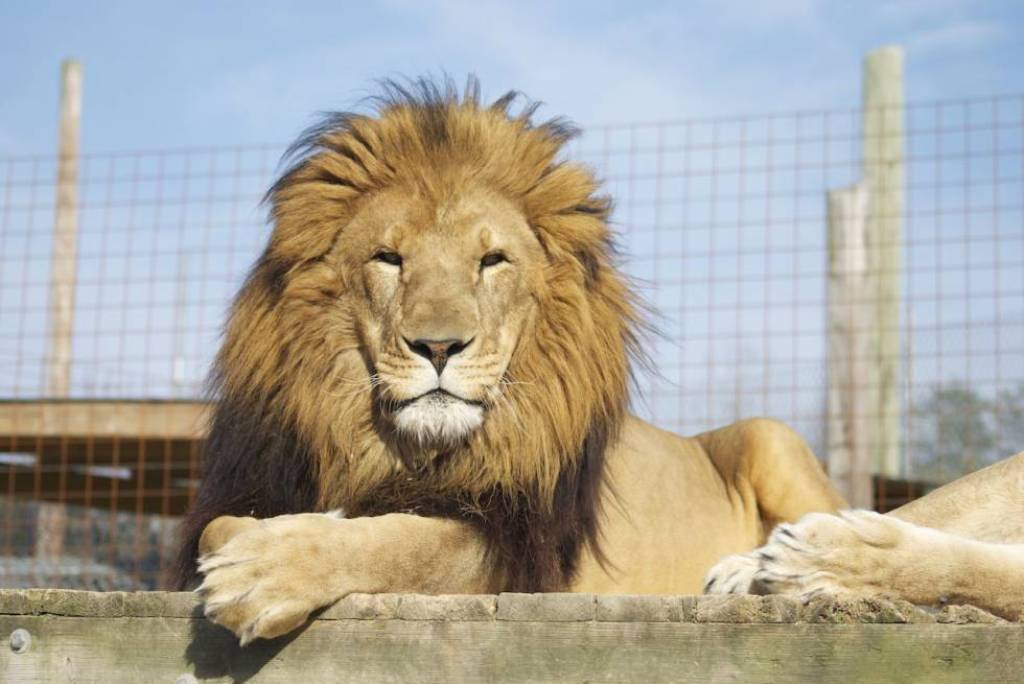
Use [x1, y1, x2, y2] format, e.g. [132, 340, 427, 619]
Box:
[332, 187, 545, 447]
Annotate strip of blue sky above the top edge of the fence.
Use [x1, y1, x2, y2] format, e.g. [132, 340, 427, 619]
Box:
[0, 0, 1024, 156]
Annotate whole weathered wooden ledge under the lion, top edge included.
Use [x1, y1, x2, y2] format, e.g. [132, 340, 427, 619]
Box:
[0, 590, 1024, 684]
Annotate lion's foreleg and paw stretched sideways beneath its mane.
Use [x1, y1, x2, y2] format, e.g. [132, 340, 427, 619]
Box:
[198, 513, 501, 645]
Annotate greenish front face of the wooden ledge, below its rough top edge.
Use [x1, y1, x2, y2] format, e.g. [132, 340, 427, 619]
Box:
[0, 615, 1024, 683]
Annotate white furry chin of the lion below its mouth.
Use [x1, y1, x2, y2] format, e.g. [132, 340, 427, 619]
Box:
[394, 393, 483, 446]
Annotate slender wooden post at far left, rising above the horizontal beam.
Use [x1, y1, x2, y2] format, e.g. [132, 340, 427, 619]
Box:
[46, 59, 82, 397]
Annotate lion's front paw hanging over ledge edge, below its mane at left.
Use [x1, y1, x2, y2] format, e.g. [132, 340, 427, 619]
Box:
[197, 513, 346, 646]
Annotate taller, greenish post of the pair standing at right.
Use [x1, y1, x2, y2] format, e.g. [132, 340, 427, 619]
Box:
[863, 45, 904, 477]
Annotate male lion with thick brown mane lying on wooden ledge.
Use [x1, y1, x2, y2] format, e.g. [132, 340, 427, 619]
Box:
[176, 81, 1019, 643]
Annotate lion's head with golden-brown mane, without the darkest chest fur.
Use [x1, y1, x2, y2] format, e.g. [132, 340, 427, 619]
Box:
[218, 86, 637, 511]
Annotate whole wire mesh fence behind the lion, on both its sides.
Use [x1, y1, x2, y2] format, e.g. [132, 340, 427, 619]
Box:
[0, 95, 1024, 588]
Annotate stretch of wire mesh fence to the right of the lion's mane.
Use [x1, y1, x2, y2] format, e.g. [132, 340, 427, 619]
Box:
[580, 96, 1024, 491]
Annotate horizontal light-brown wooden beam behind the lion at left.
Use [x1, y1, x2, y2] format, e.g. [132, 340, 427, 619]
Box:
[0, 400, 209, 440]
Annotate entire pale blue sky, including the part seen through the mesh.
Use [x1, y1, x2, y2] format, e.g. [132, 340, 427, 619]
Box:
[0, 0, 1024, 473]
